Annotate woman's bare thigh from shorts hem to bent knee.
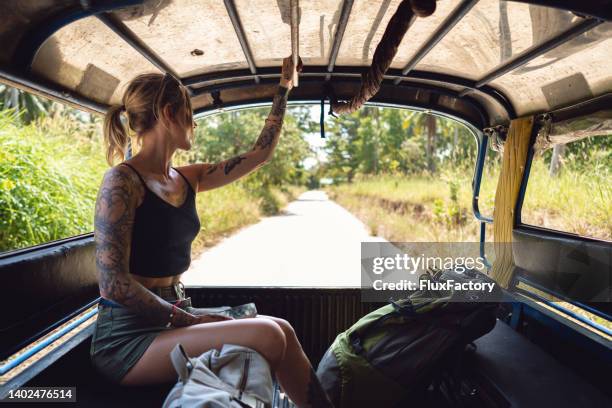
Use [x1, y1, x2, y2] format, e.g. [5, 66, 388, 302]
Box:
[121, 318, 287, 385]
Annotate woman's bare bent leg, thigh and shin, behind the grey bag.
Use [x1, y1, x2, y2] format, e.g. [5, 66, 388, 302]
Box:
[122, 316, 328, 407]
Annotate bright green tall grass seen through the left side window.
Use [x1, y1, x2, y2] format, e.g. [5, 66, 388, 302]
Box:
[0, 110, 105, 251]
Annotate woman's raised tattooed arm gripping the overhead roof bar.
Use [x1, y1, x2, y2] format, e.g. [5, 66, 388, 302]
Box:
[181, 57, 300, 191]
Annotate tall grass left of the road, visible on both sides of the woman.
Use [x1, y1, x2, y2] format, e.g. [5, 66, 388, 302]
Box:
[0, 111, 301, 255]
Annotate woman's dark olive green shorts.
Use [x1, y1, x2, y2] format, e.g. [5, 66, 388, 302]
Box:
[90, 305, 169, 383]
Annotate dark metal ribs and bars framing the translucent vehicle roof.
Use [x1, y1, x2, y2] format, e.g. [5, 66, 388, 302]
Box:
[0, 0, 612, 126]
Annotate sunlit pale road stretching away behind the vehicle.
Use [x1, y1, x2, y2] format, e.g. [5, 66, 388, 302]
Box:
[182, 191, 381, 287]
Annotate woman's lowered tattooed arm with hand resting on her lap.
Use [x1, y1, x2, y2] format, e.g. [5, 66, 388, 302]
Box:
[94, 166, 197, 326]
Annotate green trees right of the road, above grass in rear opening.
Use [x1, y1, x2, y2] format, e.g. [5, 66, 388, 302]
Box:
[322, 107, 476, 182]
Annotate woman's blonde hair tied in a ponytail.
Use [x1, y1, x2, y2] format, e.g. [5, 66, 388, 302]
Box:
[104, 74, 193, 166]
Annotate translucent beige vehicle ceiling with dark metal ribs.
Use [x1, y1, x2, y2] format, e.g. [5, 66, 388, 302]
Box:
[0, 0, 612, 127]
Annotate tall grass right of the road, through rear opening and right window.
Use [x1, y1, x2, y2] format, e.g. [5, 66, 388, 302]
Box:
[329, 160, 612, 242]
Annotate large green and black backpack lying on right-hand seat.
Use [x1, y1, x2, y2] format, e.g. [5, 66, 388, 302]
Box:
[317, 271, 501, 408]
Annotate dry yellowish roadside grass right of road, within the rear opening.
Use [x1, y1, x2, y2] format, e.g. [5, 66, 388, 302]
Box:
[328, 173, 479, 242]
